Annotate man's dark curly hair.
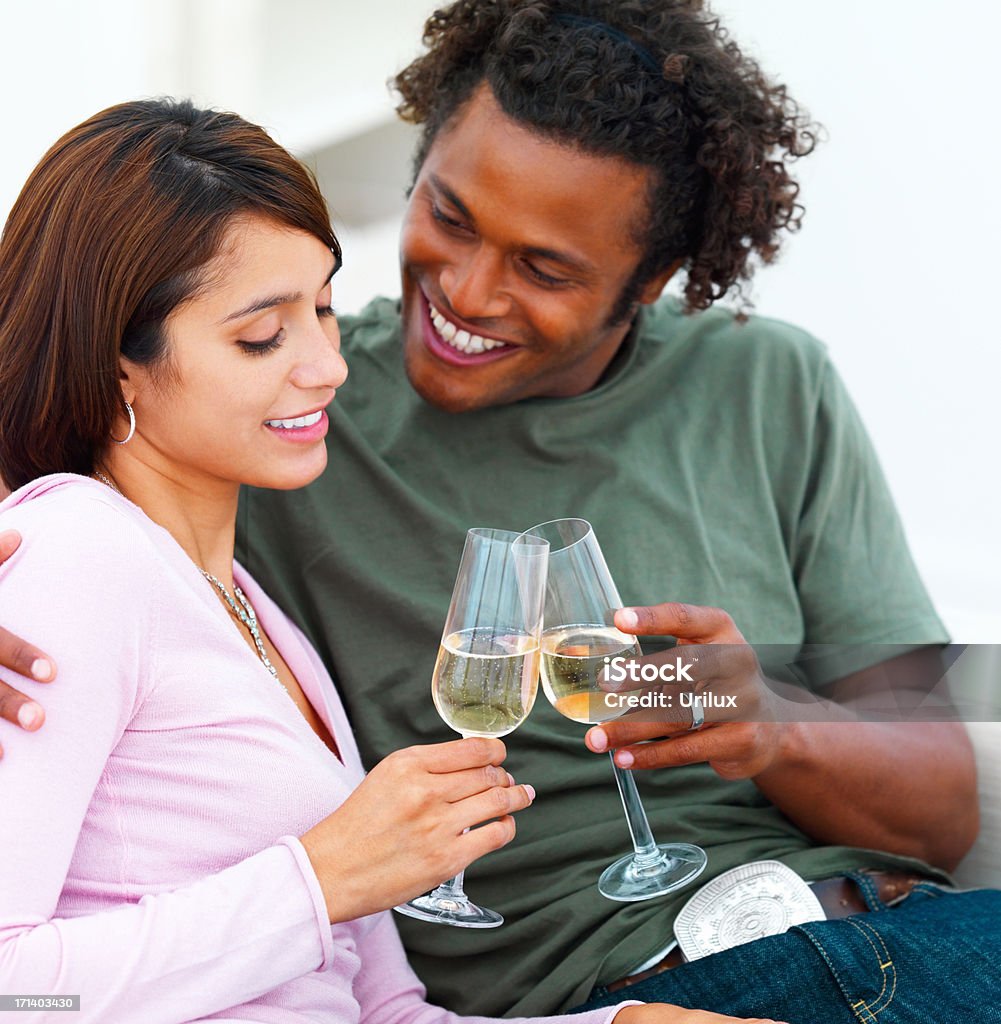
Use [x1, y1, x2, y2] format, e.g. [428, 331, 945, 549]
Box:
[395, 0, 817, 319]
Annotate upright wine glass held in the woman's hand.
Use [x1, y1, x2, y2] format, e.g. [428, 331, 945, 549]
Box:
[395, 528, 550, 928]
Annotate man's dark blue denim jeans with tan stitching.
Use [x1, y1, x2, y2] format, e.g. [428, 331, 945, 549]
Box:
[578, 883, 1001, 1024]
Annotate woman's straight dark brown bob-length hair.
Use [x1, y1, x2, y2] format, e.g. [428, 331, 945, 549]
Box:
[0, 99, 341, 487]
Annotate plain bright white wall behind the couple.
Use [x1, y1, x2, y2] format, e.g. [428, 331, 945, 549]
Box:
[0, 0, 1001, 642]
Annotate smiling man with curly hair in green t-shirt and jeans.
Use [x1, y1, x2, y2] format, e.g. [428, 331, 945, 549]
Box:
[0, 0, 986, 1021]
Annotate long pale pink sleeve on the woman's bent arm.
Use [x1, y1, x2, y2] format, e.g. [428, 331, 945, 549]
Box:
[0, 495, 332, 1024]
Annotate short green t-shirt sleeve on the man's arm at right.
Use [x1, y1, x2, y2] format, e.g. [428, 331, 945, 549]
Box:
[790, 359, 948, 685]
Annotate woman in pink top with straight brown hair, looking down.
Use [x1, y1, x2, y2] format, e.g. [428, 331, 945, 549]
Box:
[0, 101, 781, 1024]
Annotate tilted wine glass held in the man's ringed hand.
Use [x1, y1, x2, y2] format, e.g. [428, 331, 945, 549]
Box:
[515, 519, 706, 903]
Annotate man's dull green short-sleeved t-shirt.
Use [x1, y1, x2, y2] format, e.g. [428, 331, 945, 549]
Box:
[237, 299, 946, 1014]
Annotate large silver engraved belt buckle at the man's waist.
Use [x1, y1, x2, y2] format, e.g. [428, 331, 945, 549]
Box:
[674, 860, 827, 961]
